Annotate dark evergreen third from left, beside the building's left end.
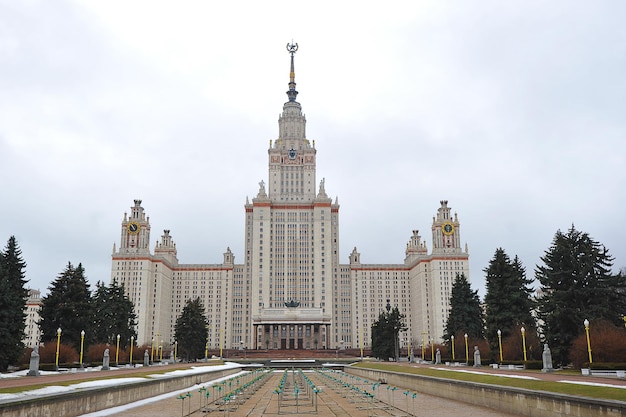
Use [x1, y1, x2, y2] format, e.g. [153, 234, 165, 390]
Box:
[93, 280, 137, 348]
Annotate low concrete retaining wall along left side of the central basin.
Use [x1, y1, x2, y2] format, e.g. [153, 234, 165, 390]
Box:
[0, 368, 241, 417]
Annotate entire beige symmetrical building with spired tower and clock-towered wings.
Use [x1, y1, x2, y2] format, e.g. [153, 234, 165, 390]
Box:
[111, 44, 469, 349]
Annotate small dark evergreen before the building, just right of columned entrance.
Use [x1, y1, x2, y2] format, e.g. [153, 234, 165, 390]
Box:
[372, 300, 407, 360]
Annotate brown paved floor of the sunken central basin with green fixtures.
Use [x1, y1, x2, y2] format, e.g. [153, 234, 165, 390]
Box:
[84, 371, 513, 417]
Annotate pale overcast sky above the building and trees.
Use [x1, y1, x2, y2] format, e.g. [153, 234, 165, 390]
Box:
[0, 0, 626, 296]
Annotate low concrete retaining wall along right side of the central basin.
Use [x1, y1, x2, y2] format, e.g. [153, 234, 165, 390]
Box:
[345, 367, 626, 417]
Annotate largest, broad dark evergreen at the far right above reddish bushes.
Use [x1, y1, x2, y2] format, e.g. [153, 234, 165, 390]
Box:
[535, 225, 626, 365]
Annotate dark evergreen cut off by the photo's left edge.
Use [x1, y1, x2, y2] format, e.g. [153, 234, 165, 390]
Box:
[0, 236, 28, 371]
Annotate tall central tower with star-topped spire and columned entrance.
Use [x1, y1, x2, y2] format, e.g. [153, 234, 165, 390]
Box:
[245, 44, 339, 349]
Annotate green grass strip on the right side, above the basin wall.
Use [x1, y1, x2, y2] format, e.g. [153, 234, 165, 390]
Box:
[354, 362, 626, 401]
